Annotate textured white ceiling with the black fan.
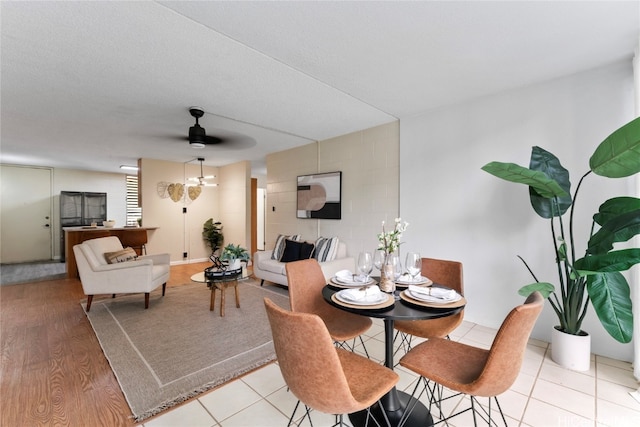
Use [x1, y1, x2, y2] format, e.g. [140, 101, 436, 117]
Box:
[0, 1, 640, 173]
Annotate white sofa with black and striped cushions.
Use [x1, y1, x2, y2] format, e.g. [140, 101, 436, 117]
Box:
[253, 242, 356, 286]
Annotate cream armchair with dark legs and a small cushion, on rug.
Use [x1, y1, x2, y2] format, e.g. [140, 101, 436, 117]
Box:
[73, 236, 170, 312]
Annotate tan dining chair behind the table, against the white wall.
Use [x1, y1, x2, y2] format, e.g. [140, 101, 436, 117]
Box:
[394, 258, 464, 351]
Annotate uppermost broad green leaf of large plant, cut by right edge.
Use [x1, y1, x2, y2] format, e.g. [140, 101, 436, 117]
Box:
[589, 117, 640, 178]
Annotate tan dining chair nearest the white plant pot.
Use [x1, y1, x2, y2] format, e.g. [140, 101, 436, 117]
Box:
[400, 292, 544, 426]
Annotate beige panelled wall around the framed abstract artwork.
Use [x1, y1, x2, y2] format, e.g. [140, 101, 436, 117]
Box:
[265, 122, 399, 257]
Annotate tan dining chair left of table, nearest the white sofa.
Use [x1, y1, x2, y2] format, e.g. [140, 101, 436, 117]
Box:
[285, 259, 373, 357]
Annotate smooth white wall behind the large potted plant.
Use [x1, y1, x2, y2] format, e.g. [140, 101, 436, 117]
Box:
[400, 62, 637, 361]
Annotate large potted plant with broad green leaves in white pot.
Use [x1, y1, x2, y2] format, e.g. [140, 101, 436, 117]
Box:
[482, 118, 640, 370]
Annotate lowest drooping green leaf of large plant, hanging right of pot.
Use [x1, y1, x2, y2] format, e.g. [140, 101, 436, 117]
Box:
[587, 272, 633, 343]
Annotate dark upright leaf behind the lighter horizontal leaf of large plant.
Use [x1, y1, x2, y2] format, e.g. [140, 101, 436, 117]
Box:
[529, 146, 571, 218]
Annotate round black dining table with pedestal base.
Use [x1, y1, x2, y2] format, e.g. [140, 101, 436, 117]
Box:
[322, 284, 464, 427]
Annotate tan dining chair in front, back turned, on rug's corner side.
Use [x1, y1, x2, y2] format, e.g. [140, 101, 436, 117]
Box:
[264, 298, 399, 426]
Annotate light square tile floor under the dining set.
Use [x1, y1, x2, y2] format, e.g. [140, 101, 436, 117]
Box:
[141, 319, 640, 427]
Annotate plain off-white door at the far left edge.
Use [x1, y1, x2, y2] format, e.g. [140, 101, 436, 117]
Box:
[0, 165, 52, 264]
